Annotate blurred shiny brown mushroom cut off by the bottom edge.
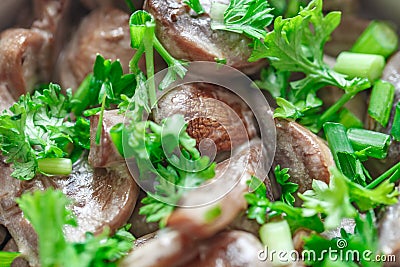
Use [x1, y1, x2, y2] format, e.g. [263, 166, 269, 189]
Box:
[185, 231, 272, 267]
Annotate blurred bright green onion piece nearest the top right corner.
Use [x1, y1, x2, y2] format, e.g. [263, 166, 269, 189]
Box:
[351, 21, 398, 57]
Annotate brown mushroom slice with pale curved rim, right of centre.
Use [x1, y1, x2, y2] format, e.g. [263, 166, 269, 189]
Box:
[274, 119, 335, 199]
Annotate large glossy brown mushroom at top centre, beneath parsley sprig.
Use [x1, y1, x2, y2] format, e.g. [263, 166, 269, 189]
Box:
[144, 0, 264, 73]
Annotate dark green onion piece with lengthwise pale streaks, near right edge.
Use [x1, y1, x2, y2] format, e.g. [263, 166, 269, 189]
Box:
[347, 128, 390, 159]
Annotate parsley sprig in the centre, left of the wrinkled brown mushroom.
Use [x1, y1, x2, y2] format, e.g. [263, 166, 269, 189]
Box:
[125, 115, 215, 227]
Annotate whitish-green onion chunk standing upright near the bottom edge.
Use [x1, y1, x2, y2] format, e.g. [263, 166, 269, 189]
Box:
[260, 220, 294, 266]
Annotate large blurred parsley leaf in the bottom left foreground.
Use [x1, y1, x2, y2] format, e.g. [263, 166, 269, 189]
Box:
[16, 189, 134, 267]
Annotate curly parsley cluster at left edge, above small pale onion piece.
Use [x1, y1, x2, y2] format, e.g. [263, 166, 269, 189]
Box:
[0, 84, 80, 180]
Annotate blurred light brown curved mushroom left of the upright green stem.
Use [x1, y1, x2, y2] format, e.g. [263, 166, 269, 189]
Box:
[58, 7, 134, 90]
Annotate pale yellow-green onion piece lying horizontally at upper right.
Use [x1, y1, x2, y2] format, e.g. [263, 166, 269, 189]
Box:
[334, 52, 385, 82]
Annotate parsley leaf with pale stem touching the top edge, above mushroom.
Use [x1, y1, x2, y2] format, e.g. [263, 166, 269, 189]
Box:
[211, 0, 274, 40]
